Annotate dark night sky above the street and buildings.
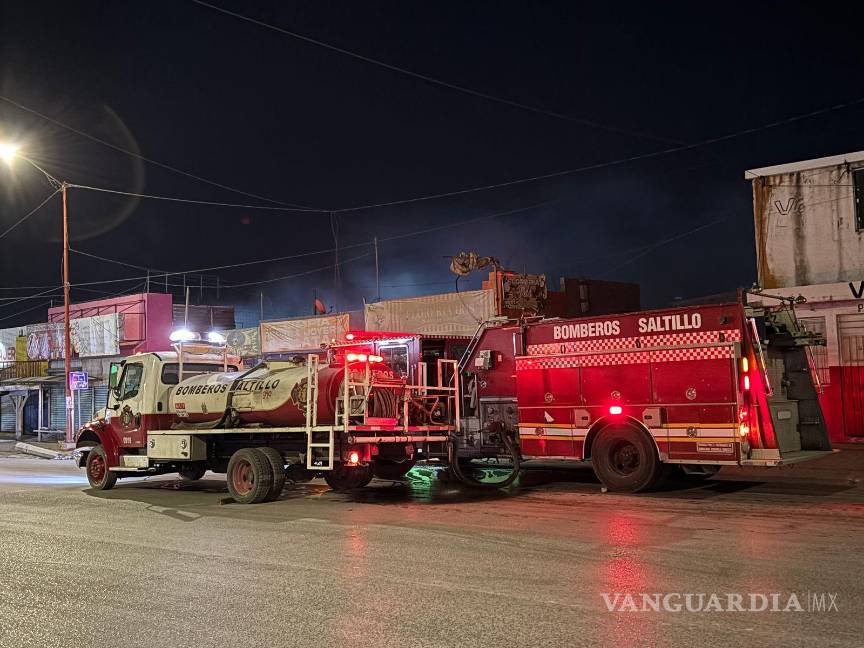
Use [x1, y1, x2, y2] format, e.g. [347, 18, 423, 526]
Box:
[0, 0, 864, 327]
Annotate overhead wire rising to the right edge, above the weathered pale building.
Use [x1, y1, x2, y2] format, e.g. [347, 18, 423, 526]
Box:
[328, 94, 864, 213]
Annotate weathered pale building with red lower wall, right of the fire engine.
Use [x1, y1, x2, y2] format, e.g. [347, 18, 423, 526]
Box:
[744, 151, 864, 442]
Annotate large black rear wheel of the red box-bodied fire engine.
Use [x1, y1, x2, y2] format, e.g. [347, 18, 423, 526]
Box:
[591, 425, 664, 493]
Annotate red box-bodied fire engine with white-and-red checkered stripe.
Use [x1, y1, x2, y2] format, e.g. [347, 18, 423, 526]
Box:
[450, 294, 831, 492]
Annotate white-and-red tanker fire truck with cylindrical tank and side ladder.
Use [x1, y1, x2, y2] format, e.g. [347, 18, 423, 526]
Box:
[76, 341, 460, 503]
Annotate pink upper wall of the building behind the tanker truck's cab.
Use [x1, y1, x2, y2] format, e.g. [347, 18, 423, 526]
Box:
[48, 293, 173, 355]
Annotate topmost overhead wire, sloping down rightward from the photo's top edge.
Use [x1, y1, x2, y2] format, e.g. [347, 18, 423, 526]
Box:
[192, 0, 674, 142]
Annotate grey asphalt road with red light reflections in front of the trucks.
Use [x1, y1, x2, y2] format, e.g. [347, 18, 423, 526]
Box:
[0, 456, 864, 648]
